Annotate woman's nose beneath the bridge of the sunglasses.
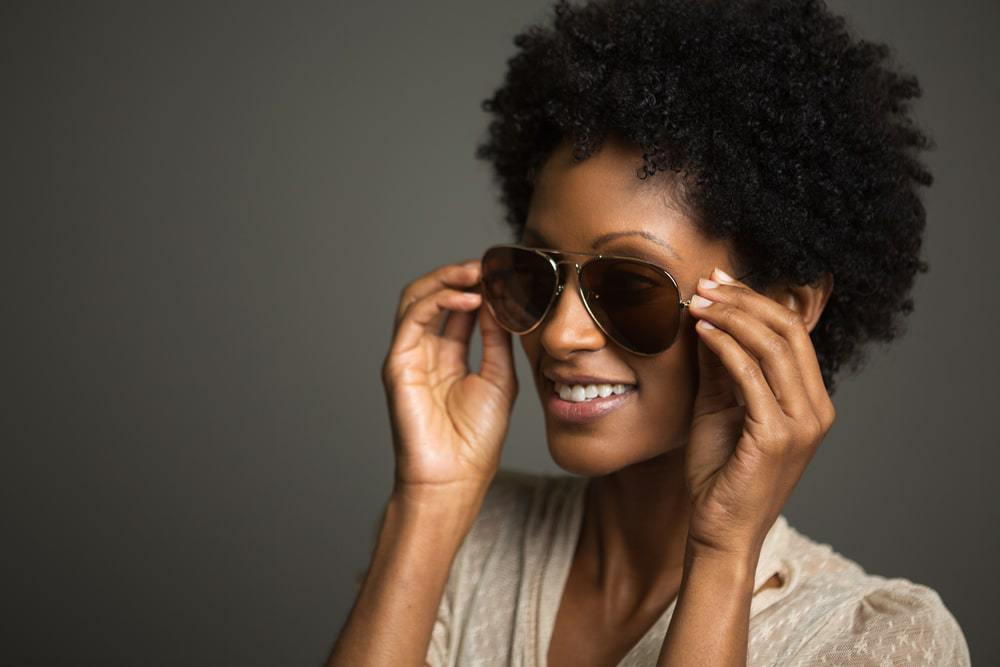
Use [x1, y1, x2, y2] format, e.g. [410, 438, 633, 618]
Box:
[541, 262, 607, 359]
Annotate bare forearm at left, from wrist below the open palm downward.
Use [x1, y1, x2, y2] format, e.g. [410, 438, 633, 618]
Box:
[327, 490, 485, 667]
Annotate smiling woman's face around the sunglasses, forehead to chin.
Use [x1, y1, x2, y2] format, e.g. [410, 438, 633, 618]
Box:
[520, 136, 738, 477]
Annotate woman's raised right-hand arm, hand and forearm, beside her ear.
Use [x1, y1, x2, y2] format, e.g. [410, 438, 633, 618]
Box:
[659, 269, 835, 665]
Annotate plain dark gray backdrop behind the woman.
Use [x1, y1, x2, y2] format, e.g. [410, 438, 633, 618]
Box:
[0, 0, 1000, 665]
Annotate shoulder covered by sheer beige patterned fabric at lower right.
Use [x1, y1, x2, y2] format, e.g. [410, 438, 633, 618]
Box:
[786, 527, 970, 665]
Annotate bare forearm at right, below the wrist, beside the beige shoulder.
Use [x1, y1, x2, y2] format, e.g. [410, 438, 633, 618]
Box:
[657, 545, 759, 667]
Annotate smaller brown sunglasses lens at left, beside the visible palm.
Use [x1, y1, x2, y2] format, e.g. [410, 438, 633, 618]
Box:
[482, 248, 557, 333]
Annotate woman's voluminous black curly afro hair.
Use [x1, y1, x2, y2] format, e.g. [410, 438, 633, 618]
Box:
[476, 0, 933, 395]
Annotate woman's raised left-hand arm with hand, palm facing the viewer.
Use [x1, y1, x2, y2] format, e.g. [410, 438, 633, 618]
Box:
[338, 260, 518, 667]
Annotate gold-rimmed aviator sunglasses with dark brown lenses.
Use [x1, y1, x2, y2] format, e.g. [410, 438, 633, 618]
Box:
[480, 244, 750, 356]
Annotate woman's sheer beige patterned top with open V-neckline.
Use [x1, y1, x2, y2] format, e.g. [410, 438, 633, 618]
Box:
[412, 470, 970, 667]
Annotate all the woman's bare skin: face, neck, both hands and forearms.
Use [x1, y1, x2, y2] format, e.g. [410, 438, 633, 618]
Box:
[328, 136, 834, 665]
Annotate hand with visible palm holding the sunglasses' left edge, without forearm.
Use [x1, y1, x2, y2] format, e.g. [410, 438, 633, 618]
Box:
[382, 260, 518, 498]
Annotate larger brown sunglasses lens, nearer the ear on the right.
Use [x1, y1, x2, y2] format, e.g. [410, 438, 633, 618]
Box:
[580, 258, 680, 354]
